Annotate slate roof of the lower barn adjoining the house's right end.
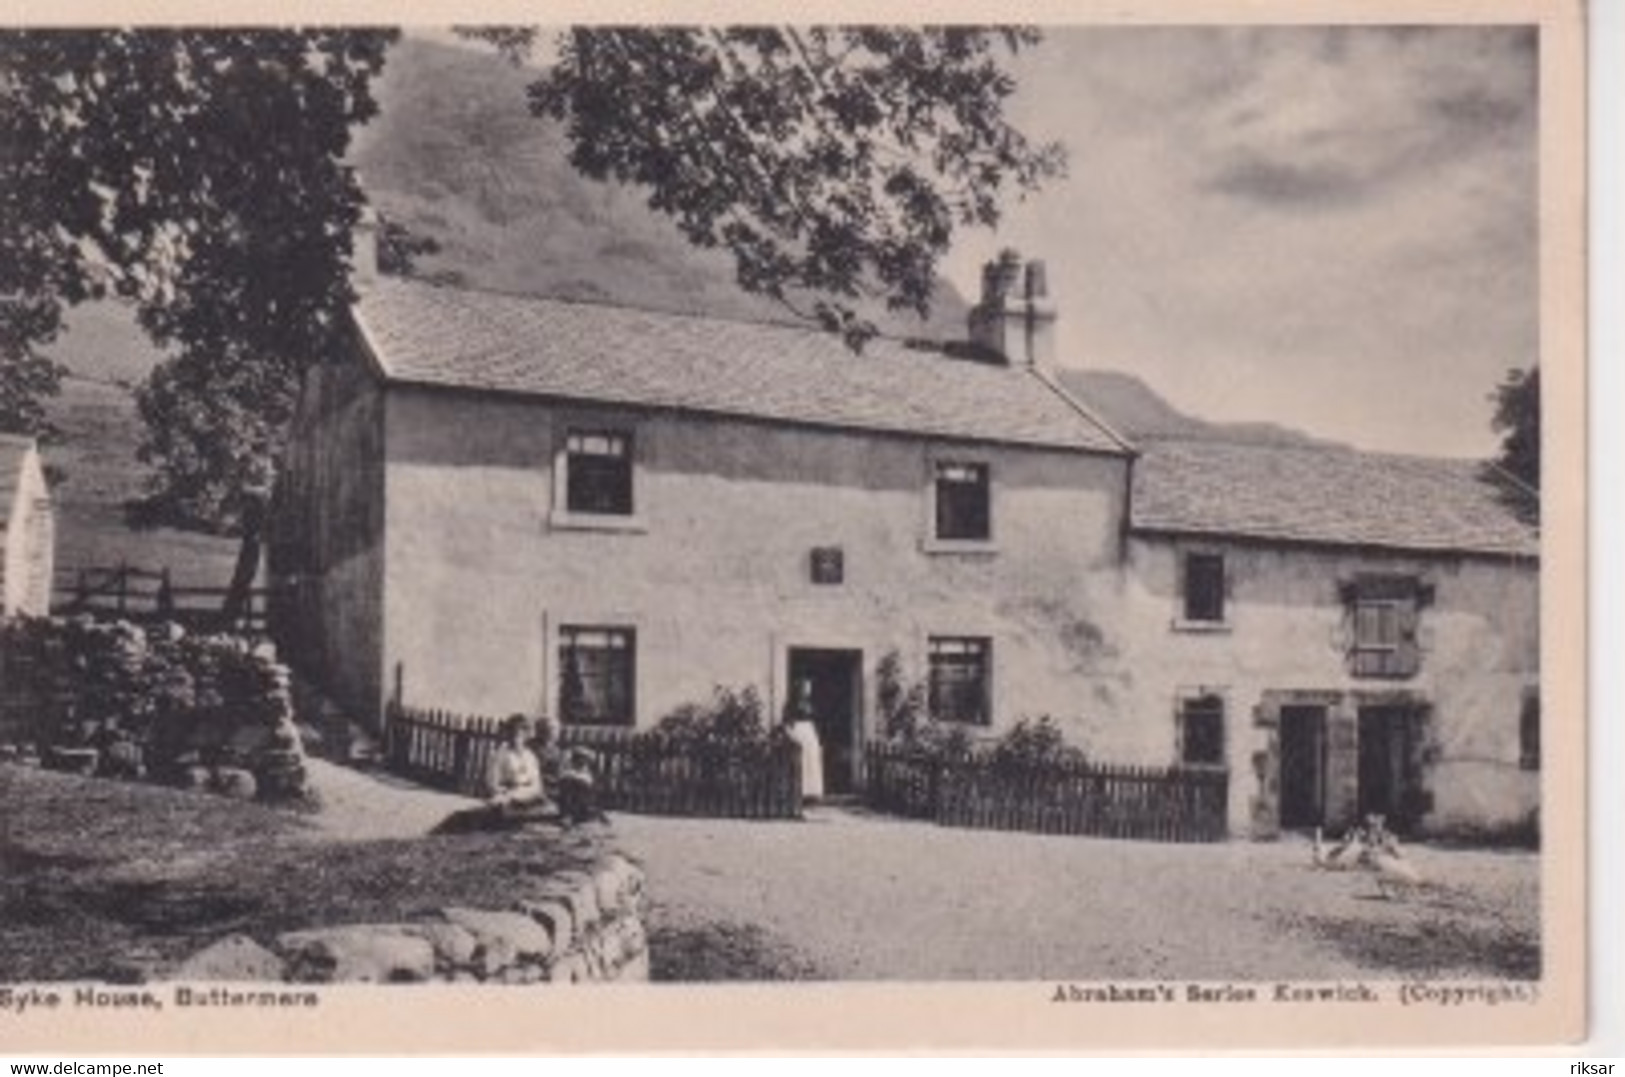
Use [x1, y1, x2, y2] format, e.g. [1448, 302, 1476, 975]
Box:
[1131, 440, 1541, 557]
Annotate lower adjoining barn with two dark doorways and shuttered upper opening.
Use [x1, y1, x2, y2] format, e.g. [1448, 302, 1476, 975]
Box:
[1128, 440, 1541, 837]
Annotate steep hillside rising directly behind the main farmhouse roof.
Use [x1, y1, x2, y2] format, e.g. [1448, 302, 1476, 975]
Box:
[353, 39, 967, 338]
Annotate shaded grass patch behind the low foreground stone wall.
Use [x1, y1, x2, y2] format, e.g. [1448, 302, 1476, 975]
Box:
[0, 765, 603, 983]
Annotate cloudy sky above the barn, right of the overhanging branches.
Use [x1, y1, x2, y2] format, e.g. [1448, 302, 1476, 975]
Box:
[946, 26, 1539, 456]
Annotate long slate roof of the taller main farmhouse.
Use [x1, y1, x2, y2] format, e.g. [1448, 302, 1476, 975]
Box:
[356, 278, 1126, 453]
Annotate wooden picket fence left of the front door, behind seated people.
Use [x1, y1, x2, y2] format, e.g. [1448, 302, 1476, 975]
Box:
[385, 707, 801, 819]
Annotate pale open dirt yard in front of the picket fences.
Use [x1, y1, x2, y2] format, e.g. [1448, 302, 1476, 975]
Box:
[614, 809, 1541, 980]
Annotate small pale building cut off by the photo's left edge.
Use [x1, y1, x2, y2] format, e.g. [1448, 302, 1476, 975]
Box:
[0, 434, 57, 617]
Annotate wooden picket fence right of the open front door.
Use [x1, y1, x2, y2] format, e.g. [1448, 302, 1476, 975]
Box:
[865, 742, 1230, 841]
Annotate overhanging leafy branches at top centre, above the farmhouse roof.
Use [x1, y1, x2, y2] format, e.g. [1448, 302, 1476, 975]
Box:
[463, 26, 1064, 346]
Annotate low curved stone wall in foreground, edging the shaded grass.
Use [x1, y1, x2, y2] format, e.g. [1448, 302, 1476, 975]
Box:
[160, 854, 648, 984]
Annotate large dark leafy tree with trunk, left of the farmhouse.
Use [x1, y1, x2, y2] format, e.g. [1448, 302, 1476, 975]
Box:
[0, 29, 395, 611]
